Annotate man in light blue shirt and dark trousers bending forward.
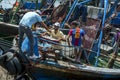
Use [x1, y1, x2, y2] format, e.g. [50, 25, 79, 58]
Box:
[19, 10, 48, 56]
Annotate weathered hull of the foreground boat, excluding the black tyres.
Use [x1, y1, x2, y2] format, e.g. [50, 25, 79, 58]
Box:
[27, 61, 120, 80]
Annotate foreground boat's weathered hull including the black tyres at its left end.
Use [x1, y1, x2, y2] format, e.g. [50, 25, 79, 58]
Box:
[0, 21, 120, 80]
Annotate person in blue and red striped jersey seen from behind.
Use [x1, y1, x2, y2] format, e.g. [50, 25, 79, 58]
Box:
[67, 21, 85, 63]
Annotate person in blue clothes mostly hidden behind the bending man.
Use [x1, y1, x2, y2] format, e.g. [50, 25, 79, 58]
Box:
[21, 23, 41, 59]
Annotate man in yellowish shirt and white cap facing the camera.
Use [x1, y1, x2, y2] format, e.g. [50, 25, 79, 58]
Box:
[44, 22, 66, 59]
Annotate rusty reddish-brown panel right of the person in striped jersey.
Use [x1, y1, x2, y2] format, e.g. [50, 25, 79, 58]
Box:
[82, 18, 101, 49]
